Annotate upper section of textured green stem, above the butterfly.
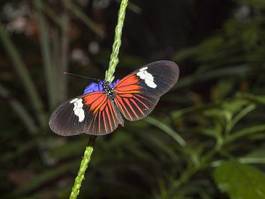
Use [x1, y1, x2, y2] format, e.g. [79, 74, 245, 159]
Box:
[105, 0, 128, 82]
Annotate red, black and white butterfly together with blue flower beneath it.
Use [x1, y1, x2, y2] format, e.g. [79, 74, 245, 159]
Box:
[49, 60, 179, 136]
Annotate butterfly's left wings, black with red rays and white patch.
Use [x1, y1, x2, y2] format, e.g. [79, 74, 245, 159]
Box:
[49, 92, 124, 136]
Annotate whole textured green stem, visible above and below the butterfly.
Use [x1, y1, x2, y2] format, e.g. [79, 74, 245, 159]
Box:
[70, 0, 128, 199]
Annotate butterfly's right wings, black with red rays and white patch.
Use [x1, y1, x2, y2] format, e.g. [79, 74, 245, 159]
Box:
[114, 61, 179, 121]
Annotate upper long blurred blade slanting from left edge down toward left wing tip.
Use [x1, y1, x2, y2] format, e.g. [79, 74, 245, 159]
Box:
[0, 23, 47, 127]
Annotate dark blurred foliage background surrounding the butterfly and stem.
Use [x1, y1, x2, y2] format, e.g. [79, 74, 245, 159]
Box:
[0, 0, 265, 199]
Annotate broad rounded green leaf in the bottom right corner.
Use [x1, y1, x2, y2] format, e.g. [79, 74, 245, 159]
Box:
[214, 161, 265, 199]
